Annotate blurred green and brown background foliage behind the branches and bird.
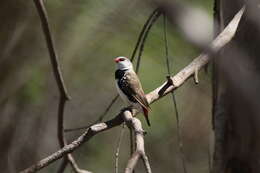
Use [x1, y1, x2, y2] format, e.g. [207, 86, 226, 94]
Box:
[0, 0, 213, 173]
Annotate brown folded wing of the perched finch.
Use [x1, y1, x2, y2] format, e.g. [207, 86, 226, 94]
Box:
[125, 71, 150, 109]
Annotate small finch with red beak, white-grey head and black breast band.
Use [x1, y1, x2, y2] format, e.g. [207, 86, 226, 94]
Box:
[114, 56, 151, 126]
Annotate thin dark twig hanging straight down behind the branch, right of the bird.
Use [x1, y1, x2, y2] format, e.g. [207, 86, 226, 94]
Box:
[163, 15, 187, 173]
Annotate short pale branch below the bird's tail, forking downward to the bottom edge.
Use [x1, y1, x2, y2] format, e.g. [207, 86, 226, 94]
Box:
[124, 111, 152, 173]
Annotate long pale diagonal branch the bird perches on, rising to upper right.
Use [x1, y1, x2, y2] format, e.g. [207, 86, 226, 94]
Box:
[21, 7, 244, 173]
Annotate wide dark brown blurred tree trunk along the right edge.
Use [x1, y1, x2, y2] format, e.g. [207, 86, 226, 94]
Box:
[212, 0, 260, 173]
